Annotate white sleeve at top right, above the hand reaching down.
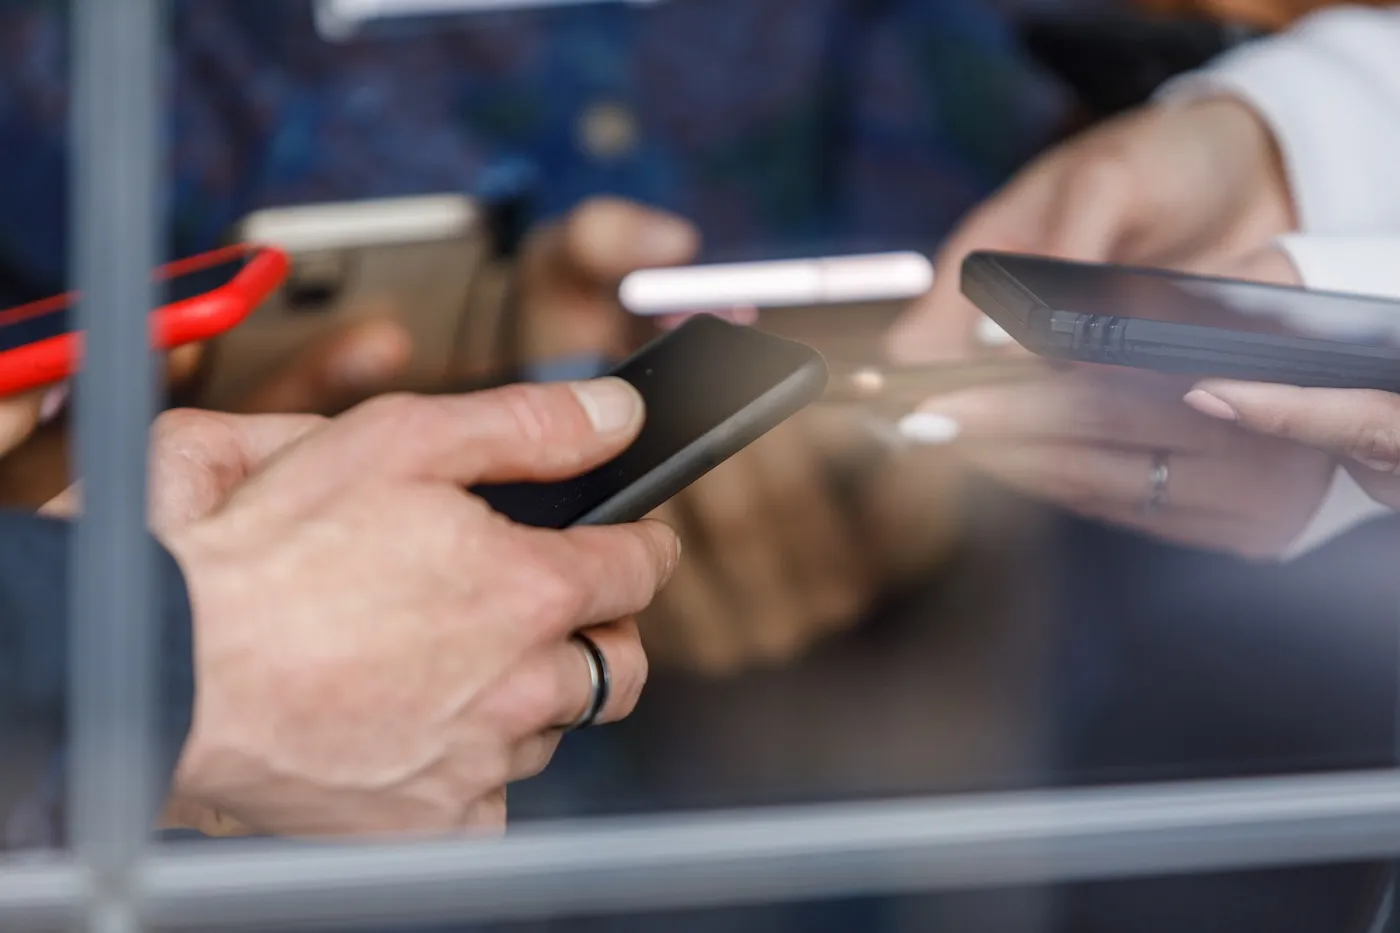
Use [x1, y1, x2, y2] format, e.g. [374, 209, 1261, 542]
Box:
[1158, 7, 1400, 234]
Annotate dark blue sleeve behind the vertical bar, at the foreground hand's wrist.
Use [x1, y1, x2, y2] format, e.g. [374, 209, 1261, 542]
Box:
[0, 511, 195, 850]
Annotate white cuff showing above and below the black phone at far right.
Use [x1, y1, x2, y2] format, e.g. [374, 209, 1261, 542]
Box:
[1278, 237, 1400, 559]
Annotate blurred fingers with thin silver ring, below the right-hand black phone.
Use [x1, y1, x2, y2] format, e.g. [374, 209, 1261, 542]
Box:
[923, 367, 1334, 558]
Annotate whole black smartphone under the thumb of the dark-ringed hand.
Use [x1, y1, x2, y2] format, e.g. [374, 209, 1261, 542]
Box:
[472, 315, 826, 528]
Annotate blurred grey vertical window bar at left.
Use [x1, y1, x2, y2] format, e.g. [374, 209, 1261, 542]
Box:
[69, 0, 161, 933]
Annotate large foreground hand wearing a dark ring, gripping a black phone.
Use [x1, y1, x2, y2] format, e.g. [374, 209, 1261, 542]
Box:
[144, 380, 678, 835]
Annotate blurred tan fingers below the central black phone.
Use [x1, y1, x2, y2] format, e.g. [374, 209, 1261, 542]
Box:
[643, 410, 881, 675]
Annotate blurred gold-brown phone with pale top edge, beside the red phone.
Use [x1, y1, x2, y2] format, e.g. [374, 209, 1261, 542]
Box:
[199, 195, 491, 409]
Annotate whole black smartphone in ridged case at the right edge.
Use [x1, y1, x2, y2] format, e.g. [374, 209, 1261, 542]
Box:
[962, 252, 1400, 392]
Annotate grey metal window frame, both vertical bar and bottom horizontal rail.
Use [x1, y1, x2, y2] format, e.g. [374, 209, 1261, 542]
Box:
[30, 0, 1400, 933]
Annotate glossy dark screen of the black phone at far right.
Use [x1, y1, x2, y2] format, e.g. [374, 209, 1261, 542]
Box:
[997, 255, 1400, 349]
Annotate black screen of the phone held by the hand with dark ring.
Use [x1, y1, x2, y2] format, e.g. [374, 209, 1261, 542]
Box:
[473, 315, 826, 528]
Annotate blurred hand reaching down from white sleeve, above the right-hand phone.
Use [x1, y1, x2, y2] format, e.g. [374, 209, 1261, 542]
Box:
[889, 98, 1295, 360]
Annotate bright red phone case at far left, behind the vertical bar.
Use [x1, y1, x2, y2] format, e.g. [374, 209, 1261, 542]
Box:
[0, 244, 291, 396]
